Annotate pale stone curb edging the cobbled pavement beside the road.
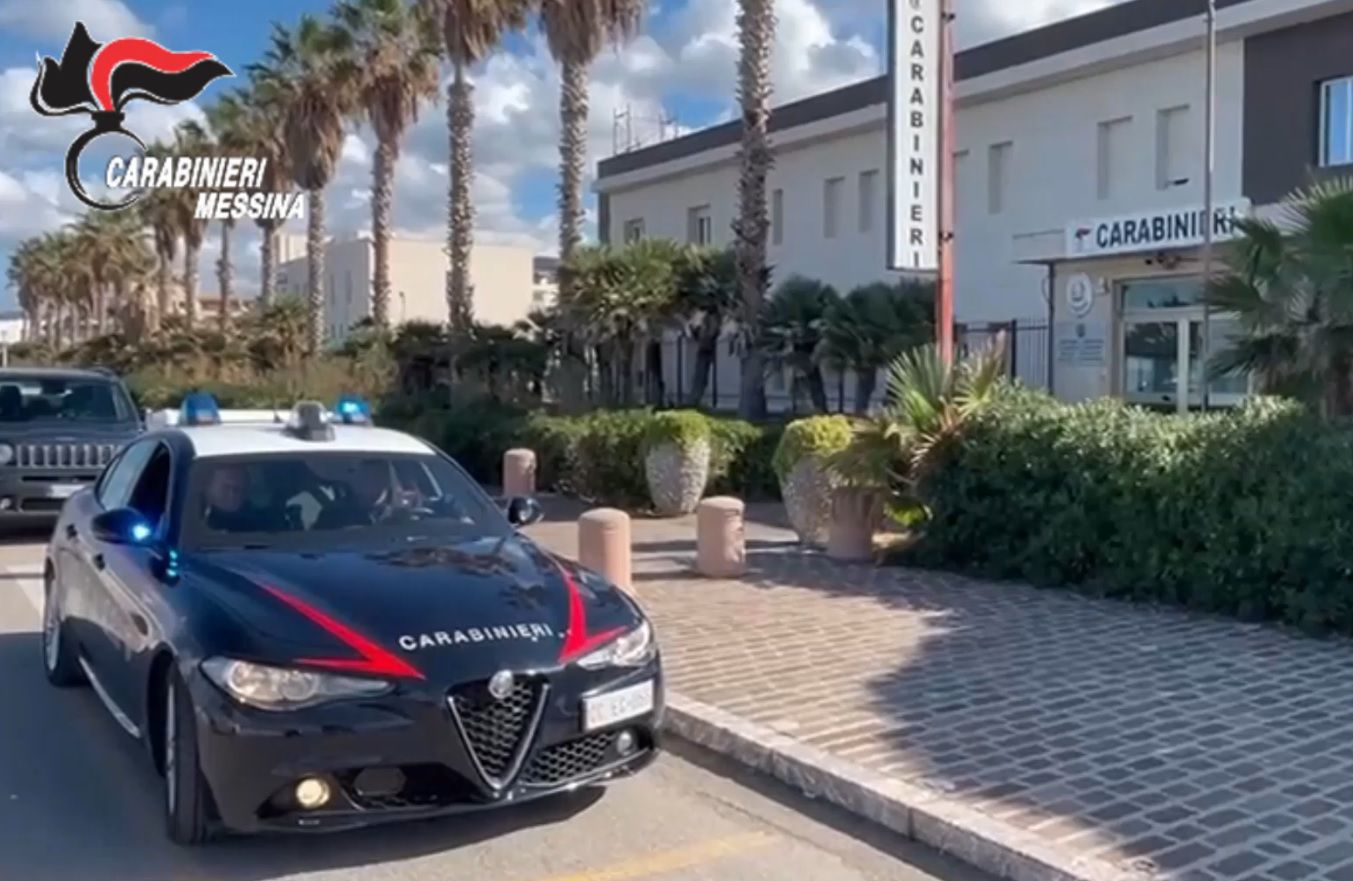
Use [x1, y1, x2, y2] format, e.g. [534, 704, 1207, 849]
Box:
[664, 692, 1150, 881]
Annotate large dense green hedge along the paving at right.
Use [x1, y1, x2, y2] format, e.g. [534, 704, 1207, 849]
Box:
[912, 391, 1353, 632]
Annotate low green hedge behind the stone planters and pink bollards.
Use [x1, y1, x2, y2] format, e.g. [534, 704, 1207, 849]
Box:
[376, 401, 782, 507]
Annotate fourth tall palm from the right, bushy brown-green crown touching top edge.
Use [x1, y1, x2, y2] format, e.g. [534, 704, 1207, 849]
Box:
[334, 0, 440, 327]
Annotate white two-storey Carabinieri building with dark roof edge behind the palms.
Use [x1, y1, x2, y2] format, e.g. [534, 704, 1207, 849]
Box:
[597, 0, 1353, 407]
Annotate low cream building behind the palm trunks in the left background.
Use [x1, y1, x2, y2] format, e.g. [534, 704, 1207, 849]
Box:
[277, 234, 536, 342]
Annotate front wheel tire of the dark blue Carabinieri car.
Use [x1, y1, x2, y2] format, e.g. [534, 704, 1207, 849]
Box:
[164, 673, 211, 847]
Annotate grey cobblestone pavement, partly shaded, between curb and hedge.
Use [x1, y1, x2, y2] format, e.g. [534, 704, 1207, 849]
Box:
[530, 503, 1353, 881]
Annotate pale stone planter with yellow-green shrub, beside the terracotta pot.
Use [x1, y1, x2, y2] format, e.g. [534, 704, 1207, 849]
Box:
[773, 415, 852, 547]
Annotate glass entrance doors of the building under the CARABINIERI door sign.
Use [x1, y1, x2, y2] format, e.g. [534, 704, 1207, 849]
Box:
[1119, 276, 1250, 410]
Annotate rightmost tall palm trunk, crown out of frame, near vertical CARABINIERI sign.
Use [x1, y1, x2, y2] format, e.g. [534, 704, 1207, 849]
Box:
[733, 0, 775, 420]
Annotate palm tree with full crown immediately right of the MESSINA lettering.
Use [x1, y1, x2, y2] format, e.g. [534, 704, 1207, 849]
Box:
[253, 15, 356, 353]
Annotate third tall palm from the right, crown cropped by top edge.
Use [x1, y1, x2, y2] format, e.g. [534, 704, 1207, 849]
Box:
[419, 0, 534, 336]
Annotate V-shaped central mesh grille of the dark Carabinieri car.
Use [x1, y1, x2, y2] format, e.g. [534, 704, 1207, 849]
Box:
[449, 679, 545, 786]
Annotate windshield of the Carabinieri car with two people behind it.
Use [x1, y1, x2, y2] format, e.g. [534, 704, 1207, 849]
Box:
[184, 453, 511, 549]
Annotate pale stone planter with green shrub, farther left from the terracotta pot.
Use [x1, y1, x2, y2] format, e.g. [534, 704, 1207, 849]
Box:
[644, 410, 712, 517]
